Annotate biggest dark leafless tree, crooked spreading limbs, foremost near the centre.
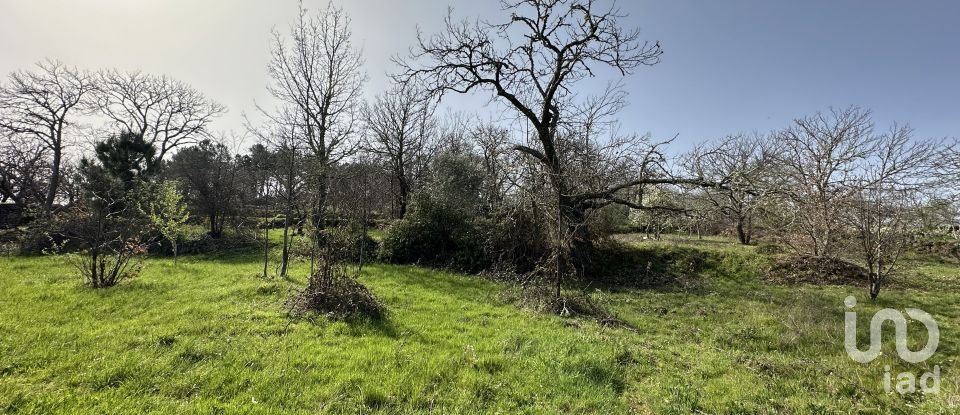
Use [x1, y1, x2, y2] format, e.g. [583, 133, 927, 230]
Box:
[397, 0, 732, 295]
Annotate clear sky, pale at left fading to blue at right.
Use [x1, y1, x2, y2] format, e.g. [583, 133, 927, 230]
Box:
[0, 0, 960, 153]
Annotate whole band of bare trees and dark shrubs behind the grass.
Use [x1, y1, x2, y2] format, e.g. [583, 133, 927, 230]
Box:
[0, 0, 960, 306]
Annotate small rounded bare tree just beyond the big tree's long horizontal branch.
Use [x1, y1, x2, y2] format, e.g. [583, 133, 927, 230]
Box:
[687, 134, 776, 245]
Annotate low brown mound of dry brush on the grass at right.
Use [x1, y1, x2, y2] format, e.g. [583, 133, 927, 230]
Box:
[768, 255, 869, 286]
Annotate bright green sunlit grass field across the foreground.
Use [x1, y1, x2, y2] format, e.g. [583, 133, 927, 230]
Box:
[0, 234, 960, 414]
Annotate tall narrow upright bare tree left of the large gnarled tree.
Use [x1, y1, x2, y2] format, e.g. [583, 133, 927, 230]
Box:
[260, 2, 366, 229]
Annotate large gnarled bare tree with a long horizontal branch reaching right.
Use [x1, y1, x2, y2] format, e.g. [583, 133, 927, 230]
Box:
[398, 0, 728, 295]
